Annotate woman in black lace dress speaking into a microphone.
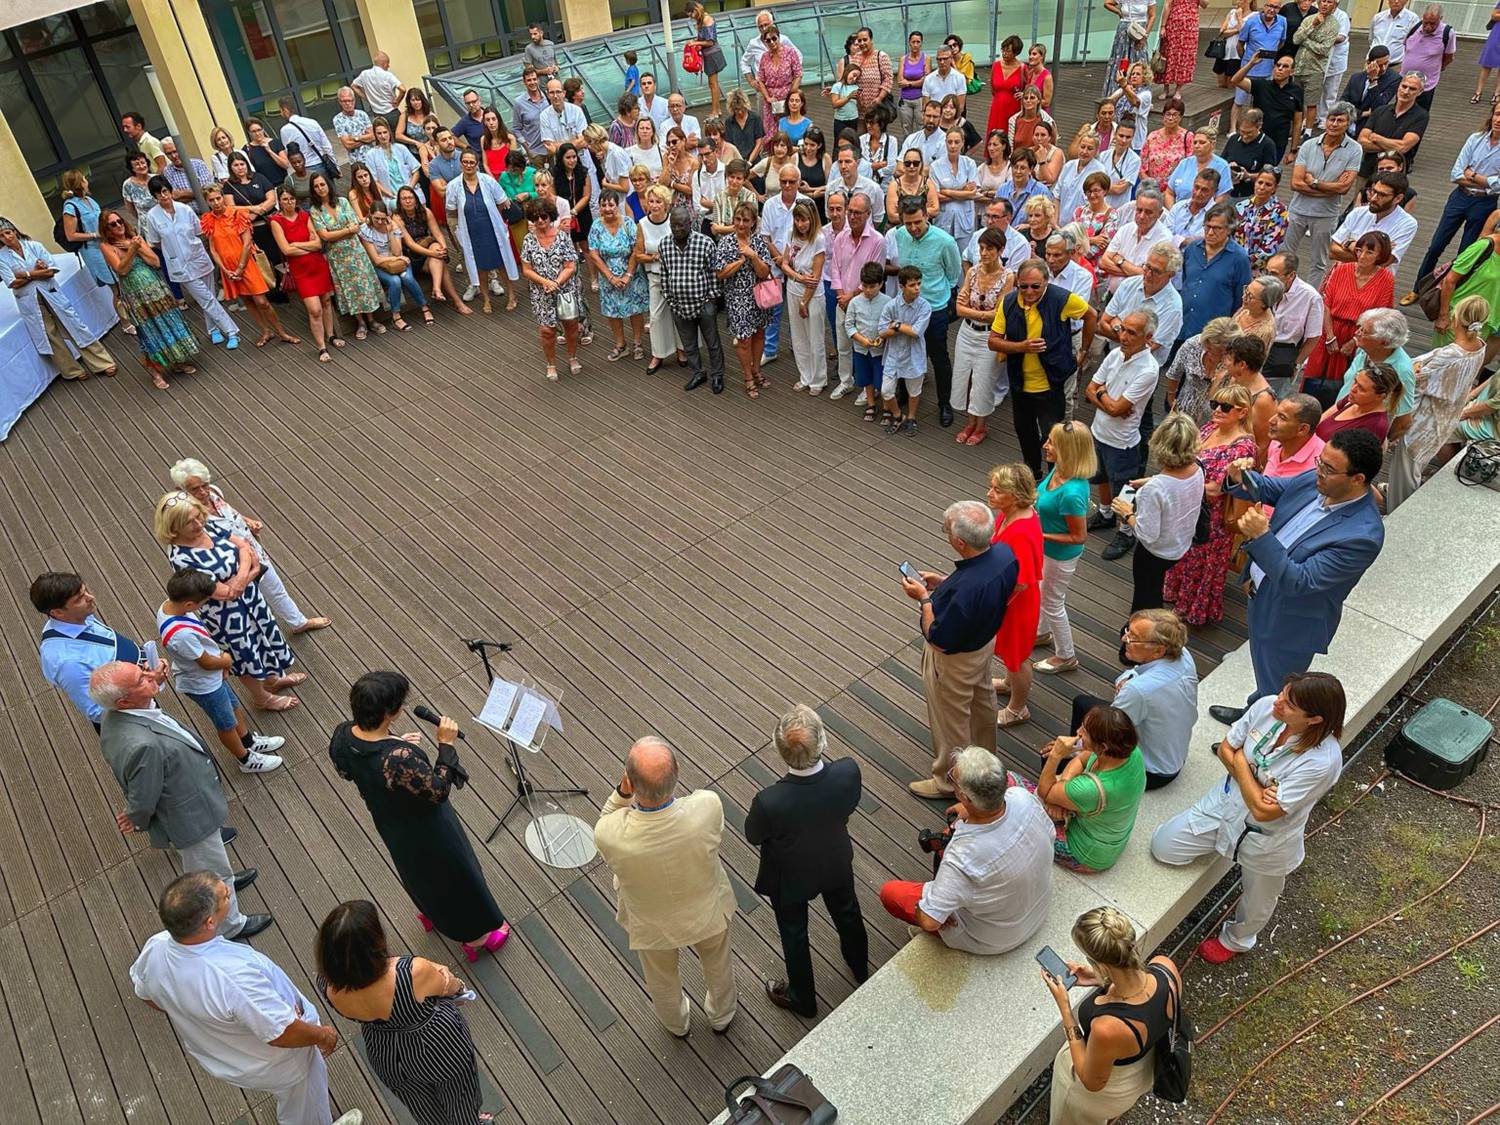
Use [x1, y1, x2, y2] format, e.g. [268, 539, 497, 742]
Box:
[329, 672, 510, 962]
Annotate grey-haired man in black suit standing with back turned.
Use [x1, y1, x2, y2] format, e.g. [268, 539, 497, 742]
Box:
[746, 704, 870, 1016]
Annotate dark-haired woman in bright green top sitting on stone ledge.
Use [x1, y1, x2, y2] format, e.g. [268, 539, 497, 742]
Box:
[1037, 707, 1146, 873]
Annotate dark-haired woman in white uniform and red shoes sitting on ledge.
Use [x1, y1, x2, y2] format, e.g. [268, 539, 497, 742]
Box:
[1151, 672, 1344, 965]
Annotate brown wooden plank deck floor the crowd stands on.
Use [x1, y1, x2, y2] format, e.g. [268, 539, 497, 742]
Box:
[0, 44, 1472, 1125]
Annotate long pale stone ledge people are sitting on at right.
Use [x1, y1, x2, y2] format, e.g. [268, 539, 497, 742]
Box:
[717, 465, 1500, 1125]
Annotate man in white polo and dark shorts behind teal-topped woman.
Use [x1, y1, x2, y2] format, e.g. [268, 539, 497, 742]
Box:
[1086, 306, 1161, 543]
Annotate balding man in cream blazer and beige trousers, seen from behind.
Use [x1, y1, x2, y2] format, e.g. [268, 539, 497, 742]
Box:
[594, 738, 738, 1038]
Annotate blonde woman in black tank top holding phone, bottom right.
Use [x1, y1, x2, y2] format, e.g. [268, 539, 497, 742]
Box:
[1041, 906, 1182, 1125]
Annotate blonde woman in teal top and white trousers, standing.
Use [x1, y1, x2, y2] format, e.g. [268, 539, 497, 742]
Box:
[1032, 422, 1098, 675]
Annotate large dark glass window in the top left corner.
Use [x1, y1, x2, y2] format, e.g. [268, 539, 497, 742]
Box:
[0, 0, 153, 213]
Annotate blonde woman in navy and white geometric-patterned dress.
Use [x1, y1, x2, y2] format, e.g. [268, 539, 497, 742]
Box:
[152, 491, 308, 711]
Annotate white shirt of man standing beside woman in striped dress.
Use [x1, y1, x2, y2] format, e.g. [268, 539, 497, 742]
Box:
[131, 930, 318, 1089]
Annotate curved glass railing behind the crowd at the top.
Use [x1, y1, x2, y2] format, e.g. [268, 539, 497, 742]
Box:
[428, 0, 1086, 122]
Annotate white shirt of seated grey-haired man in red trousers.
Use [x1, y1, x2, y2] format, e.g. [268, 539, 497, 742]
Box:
[917, 785, 1056, 954]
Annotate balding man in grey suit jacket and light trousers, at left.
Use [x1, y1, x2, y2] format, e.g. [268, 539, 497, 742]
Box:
[89, 660, 272, 941]
